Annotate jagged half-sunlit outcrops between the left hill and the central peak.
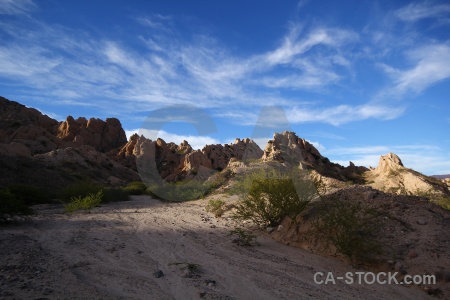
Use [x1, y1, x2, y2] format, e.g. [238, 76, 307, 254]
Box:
[125, 135, 263, 181]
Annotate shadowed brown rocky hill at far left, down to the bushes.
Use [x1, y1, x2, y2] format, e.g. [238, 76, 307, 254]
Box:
[0, 97, 139, 186]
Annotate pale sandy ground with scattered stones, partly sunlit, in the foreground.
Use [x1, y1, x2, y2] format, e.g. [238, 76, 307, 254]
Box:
[0, 196, 434, 299]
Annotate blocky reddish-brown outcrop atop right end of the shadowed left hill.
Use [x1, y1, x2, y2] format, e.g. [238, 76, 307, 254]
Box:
[57, 116, 127, 152]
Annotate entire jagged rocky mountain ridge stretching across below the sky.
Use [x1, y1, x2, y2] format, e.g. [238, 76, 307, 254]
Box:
[0, 97, 450, 199]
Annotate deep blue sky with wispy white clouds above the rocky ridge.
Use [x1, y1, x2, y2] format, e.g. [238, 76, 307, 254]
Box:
[0, 0, 450, 175]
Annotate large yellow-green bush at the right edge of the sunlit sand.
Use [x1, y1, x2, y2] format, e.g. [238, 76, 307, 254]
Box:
[233, 171, 318, 227]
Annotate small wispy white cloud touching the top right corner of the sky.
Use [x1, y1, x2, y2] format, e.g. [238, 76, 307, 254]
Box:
[395, 2, 450, 22]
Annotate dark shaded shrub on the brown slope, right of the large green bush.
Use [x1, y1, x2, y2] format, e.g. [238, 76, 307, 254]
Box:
[312, 197, 382, 264]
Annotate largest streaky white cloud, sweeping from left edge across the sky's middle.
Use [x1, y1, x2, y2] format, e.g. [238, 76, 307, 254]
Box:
[0, 3, 414, 126]
